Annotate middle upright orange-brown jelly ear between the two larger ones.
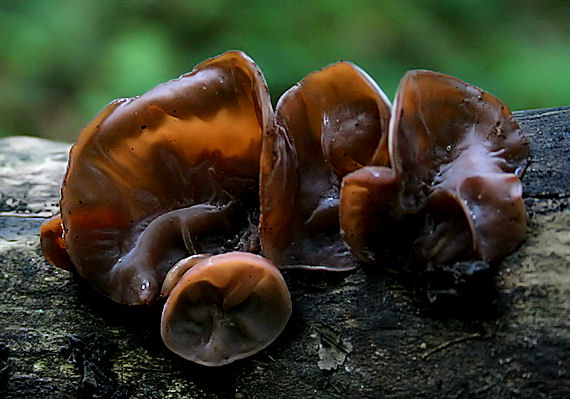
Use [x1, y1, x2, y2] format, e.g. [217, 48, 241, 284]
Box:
[260, 62, 390, 270]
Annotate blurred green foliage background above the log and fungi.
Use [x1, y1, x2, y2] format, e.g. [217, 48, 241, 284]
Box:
[0, 0, 570, 141]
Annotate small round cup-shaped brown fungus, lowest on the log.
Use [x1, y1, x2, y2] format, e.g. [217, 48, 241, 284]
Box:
[161, 252, 291, 366]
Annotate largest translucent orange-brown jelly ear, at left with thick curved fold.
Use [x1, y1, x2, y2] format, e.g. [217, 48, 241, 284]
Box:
[47, 51, 273, 304]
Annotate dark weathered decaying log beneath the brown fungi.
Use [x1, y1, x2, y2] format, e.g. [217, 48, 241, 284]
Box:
[0, 108, 570, 398]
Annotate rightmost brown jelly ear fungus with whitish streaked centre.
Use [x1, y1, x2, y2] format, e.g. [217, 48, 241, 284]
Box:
[341, 71, 529, 263]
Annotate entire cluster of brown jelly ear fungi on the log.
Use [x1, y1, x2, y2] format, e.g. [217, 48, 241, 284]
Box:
[41, 51, 528, 366]
